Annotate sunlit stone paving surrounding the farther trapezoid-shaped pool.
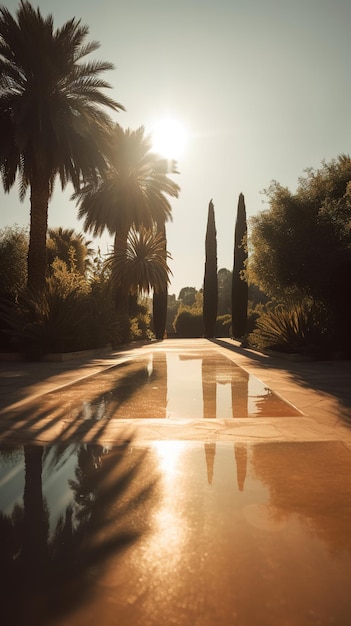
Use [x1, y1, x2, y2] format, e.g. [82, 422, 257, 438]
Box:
[0, 339, 351, 448]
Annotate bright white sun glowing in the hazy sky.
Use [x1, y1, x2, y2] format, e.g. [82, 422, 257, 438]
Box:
[151, 117, 188, 160]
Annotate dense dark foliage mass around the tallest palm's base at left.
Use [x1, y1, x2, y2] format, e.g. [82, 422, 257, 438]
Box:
[0, 228, 151, 358]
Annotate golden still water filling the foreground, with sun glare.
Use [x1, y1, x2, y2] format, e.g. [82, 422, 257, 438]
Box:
[0, 441, 351, 626]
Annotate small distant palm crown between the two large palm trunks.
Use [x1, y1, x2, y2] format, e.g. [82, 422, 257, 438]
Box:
[46, 226, 95, 276]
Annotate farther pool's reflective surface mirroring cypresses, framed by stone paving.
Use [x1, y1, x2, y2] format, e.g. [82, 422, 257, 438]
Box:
[23, 351, 299, 423]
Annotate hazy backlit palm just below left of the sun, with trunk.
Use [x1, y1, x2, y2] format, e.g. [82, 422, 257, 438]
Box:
[75, 124, 180, 314]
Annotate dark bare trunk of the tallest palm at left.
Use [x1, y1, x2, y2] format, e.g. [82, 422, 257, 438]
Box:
[27, 174, 50, 293]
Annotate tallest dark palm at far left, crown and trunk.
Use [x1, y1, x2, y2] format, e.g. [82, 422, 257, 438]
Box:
[0, 0, 123, 291]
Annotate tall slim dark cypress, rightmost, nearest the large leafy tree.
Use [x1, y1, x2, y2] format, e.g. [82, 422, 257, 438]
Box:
[232, 193, 248, 338]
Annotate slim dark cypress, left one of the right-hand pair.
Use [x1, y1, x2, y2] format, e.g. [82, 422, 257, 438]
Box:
[202, 200, 218, 338]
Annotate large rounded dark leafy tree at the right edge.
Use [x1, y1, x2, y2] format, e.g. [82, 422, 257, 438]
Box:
[250, 155, 351, 353]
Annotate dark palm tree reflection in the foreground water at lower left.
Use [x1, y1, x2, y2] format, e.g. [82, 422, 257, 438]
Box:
[0, 436, 156, 626]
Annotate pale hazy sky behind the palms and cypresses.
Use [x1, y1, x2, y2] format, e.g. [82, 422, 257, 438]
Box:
[0, 0, 351, 296]
